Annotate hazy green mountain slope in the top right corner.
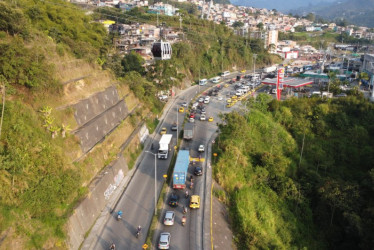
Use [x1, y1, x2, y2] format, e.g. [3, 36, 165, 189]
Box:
[290, 0, 374, 28]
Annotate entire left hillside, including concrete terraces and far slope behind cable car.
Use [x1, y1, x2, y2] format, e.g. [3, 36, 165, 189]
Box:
[0, 0, 279, 249]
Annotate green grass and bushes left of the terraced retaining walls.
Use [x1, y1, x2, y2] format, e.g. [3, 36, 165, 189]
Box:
[0, 0, 107, 249]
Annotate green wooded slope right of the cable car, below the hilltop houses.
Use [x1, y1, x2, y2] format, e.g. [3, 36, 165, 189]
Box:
[96, 4, 280, 83]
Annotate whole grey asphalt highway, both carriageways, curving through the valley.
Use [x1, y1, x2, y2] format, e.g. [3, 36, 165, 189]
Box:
[85, 71, 245, 249]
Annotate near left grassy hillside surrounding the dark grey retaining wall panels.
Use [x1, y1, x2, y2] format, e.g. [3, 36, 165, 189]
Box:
[0, 1, 151, 249]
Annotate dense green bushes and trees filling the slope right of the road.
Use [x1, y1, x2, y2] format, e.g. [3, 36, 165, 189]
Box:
[214, 95, 374, 249]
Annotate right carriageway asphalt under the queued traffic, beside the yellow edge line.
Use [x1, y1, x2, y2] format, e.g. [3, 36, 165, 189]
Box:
[153, 74, 240, 250]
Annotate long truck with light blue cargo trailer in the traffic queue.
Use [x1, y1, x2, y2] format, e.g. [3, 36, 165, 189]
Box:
[173, 150, 190, 189]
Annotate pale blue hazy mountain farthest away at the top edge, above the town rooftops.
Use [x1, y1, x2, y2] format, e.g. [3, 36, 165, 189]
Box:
[231, 0, 335, 13]
